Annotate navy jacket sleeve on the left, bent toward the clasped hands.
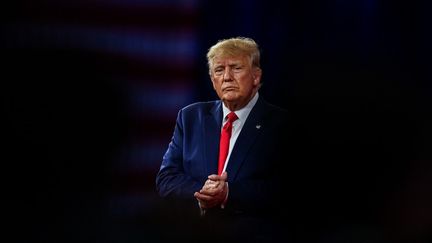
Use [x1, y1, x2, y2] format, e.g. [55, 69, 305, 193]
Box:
[156, 110, 202, 199]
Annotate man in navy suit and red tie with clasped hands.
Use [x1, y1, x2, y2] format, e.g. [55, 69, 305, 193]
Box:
[156, 37, 289, 241]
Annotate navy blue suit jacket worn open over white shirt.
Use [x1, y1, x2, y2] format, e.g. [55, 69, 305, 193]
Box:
[156, 97, 290, 217]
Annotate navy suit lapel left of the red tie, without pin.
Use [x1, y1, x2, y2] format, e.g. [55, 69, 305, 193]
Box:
[203, 101, 222, 175]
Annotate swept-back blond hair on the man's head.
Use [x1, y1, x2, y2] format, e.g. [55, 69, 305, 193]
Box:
[207, 37, 261, 71]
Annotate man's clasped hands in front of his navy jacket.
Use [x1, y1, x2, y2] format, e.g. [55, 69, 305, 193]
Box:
[194, 172, 228, 209]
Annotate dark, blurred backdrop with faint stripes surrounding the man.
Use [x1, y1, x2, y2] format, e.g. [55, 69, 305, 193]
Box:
[0, 0, 432, 242]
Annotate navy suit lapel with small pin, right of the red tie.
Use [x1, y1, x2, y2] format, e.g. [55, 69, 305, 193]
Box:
[226, 98, 265, 181]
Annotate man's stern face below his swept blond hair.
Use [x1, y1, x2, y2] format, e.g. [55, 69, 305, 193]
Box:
[210, 56, 261, 109]
